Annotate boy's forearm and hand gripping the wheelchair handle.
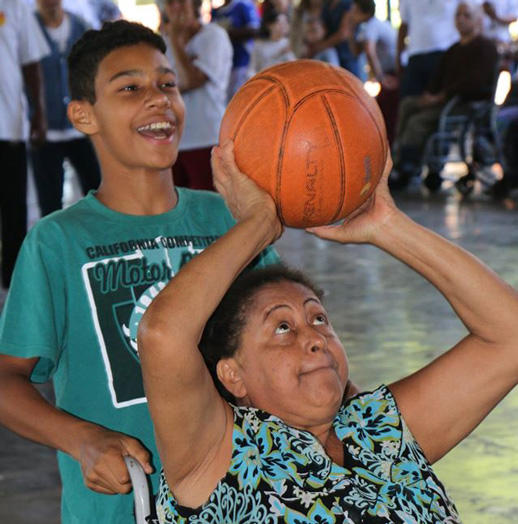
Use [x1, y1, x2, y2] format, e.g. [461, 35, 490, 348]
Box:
[0, 355, 152, 494]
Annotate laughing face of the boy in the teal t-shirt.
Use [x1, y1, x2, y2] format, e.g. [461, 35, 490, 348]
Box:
[82, 44, 185, 171]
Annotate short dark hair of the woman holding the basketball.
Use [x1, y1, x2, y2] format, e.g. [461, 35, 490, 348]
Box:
[199, 264, 324, 402]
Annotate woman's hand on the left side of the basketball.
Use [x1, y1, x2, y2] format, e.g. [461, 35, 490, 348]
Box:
[212, 140, 283, 244]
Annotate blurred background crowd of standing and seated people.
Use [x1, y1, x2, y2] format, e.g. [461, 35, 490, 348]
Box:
[0, 0, 518, 288]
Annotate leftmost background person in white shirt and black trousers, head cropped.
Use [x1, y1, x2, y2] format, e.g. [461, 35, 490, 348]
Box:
[0, 0, 50, 288]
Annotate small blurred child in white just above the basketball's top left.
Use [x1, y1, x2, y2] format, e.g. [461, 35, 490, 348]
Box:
[248, 9, 296, 78]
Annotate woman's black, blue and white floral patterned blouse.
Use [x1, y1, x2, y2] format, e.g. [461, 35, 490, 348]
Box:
[157, 386, 460, 524]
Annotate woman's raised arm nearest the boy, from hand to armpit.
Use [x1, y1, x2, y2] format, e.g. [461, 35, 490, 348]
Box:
[138, 143, 282, 506]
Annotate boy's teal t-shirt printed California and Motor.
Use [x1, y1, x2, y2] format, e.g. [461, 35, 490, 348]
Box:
[0, 188, 279, 524]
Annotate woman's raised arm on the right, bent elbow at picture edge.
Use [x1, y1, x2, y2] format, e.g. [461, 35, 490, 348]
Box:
[312, 156, 518, 463]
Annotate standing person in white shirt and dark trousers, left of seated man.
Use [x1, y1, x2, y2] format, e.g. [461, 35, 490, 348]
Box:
[396, 0, 470, 97]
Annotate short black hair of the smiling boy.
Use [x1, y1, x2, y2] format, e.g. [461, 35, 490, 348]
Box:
[68, 20, 166, 104]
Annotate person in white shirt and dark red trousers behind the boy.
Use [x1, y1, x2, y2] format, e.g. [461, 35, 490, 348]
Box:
[164, 0, 232, 190]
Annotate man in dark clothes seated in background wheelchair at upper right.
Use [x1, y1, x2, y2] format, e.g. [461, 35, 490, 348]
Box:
[391, 1, 498, 188]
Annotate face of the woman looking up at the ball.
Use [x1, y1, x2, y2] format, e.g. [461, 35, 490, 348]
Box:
[226, 282, 348, 428]
